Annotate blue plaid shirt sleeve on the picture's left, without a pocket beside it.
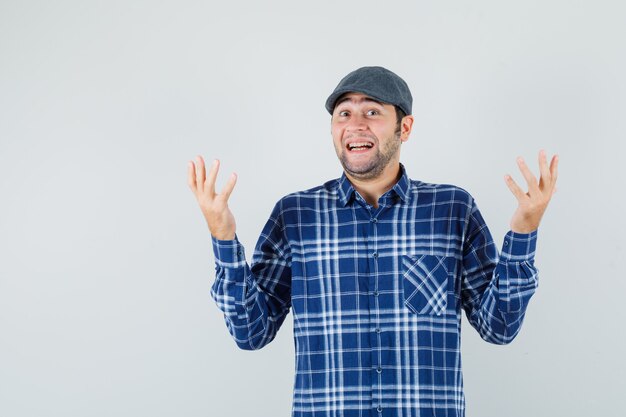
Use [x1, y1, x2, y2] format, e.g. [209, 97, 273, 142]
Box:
[211, 200, 291, 350]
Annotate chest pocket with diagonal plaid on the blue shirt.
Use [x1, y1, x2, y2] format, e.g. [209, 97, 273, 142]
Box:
[402, 255, 448, 315]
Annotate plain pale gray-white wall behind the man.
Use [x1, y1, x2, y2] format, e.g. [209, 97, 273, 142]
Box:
[0, 0, 626, 417]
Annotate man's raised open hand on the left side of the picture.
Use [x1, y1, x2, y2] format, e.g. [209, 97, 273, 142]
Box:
[187, 155, 237, 240]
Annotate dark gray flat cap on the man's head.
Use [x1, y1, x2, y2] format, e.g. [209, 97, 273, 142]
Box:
[326, 67, 413, 114]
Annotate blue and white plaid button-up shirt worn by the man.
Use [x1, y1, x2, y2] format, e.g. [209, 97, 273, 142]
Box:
[211, 166, 537, 417]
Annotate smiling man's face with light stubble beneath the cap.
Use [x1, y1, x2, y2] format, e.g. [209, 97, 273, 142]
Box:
[331, 93, 404, 180]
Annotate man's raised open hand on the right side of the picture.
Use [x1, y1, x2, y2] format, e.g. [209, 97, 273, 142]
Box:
[504, 150, 559, 233]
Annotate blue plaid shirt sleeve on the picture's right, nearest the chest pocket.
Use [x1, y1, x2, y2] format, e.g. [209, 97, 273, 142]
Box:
[461, 200, 538, 344]
